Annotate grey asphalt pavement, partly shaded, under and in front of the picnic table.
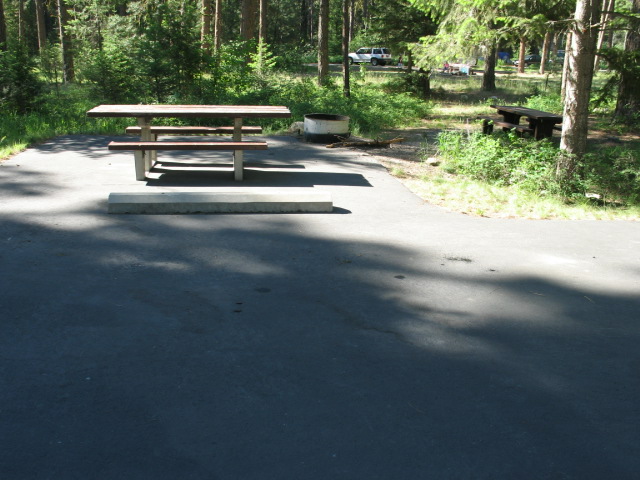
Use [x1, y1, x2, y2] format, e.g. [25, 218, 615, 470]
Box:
[0, 136, 640, 480]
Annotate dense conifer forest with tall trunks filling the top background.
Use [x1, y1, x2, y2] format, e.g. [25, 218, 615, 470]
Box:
[0, 0, 640, 161]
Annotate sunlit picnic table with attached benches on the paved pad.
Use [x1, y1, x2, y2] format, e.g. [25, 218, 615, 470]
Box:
[87, 105, 291, 180]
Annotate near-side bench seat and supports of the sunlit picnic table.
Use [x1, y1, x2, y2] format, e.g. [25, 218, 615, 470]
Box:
[108, 141, 267, 180]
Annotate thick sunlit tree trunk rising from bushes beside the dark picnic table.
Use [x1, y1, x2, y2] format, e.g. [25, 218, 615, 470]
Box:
[558, 0, 601, 165]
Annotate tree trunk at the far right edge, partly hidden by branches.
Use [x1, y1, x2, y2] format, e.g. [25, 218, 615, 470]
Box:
[614, 0, 640, 123]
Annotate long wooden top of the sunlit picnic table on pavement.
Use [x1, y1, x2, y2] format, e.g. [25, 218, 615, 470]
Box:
[87, 105, 291, 118]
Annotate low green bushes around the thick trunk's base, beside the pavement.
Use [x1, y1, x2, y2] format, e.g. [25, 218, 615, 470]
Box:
[438, 131, 640, 205]
